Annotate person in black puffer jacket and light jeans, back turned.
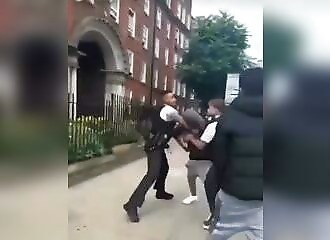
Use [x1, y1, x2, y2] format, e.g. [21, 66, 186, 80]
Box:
[211, 68, 263, 240]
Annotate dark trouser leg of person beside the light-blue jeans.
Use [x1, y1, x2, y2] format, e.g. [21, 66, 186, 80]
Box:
[204, 165, 220, 214]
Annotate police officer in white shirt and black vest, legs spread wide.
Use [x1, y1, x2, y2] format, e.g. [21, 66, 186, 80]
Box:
[123, 91, 187, 223]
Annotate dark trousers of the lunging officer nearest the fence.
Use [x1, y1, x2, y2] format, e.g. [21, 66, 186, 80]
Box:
[128, 149, 169, 207]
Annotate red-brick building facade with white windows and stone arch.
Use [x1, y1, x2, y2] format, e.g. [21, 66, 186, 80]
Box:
[68, 0, 192, 117]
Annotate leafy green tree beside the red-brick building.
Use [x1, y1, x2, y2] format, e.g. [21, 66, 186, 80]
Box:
[178, 12, 251, 107]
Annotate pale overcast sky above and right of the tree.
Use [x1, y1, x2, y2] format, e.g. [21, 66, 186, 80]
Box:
[192, 0, 263, 60]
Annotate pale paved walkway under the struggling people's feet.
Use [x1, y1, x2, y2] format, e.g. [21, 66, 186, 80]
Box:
[69, 142, 245, 240]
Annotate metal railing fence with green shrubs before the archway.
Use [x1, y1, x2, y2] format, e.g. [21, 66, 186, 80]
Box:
[68, 94, 143, 162]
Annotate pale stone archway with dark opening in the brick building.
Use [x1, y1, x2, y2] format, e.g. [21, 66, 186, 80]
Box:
[69, 17, 128, 116]
